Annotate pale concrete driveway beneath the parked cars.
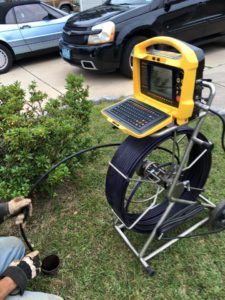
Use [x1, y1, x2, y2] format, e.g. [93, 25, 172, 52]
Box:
[0, 41, 225, 109]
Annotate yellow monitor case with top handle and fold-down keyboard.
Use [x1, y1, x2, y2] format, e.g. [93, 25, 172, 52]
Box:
[102, 37, 204, 138]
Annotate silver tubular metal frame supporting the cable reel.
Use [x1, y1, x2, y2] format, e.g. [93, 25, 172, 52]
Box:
[109, 80, 221, 276]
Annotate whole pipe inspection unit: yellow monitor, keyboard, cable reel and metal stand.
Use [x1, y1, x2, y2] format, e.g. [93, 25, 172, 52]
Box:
[102, 37, 225, 275]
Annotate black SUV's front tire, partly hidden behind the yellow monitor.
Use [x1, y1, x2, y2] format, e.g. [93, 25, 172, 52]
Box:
[120, 35, 147, 78]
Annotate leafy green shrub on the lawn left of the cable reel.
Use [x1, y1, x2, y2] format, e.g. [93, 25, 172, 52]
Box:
[0, 74, 91, 199]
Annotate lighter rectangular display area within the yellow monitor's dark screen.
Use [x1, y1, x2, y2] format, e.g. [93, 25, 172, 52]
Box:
[149, 66, 173, 100]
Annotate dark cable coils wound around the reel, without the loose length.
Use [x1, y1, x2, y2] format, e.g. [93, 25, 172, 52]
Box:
[106, 126, 212, 233]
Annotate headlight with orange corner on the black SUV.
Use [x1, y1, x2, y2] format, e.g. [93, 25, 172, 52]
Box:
[88, 21, 115, 45]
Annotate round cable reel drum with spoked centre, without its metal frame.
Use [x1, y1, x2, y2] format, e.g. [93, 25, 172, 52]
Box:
[106, 127, 211, 233]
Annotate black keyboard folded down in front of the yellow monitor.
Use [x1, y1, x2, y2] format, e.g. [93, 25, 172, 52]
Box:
[104, 99, 169, 133]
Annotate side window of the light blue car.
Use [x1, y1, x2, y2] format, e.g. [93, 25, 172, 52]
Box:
[14, 4, 48, 23]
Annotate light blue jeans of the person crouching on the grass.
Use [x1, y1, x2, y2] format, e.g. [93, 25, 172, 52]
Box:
[0, 236, 63, 300]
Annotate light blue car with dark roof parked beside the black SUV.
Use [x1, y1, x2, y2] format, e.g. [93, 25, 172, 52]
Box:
[0, 1, 71, 74]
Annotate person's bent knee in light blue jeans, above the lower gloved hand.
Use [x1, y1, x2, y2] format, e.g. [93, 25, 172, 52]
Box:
[0, 236, 25, 274]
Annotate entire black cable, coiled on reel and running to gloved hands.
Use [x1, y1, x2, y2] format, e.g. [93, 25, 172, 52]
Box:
[20, 109, 225, 247]
